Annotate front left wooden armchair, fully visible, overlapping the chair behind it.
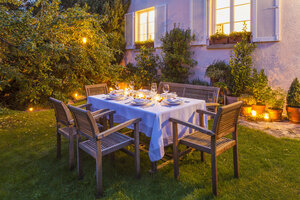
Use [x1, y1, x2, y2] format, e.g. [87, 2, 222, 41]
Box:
[68, 105, 141, 196]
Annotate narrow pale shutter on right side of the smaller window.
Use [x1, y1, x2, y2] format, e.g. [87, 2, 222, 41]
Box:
[154, 4, 167, 48]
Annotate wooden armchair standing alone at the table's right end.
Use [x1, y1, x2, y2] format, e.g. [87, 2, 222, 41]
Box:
[170, 101, 243, 195]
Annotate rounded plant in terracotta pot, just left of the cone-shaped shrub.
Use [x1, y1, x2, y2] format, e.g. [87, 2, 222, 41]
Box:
[267, 88, 285, 121]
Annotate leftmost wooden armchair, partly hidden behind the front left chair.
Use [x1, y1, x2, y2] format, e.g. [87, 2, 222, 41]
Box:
[49, 97, 108, 169]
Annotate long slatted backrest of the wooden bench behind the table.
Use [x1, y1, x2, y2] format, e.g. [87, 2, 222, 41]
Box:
[158, 82, 220, 103]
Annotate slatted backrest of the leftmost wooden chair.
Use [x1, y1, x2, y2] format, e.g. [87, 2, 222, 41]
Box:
[49, 97, 72, 126]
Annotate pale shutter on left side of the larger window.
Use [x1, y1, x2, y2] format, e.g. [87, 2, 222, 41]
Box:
[190, 0, 207, 45]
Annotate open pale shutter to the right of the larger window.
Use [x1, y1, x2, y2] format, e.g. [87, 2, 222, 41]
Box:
[252, 0, 280, 42]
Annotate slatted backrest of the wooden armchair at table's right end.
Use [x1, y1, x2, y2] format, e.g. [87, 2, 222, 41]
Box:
[212, 101, 243, 138]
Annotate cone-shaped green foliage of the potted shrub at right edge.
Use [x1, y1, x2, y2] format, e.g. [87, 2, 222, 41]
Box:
[287, 78, 300, 108]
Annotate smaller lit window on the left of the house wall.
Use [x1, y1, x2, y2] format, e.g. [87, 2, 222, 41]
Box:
[135, 8, 155, 42]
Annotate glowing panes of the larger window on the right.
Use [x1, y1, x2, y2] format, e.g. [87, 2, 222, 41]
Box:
[214, 0, 251, 34]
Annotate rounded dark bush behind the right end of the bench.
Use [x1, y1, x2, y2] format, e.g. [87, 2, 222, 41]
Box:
[205, 60, 231, 83]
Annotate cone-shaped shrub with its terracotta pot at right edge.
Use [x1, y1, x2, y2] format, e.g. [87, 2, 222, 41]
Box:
[286, 78, 300, 123]
